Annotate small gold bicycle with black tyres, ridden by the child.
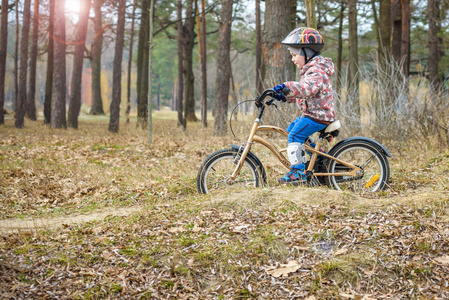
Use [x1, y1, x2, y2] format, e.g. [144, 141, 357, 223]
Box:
[197, 89, 391, 194]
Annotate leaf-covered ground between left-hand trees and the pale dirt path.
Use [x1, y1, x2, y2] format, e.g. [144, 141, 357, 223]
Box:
[0, 123, 203, 218]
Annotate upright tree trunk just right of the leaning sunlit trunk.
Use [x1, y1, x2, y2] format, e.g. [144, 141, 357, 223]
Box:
[90, 0, 104, 115]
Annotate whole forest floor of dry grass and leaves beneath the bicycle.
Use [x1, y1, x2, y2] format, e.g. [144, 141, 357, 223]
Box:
[0, 112, 449, 299]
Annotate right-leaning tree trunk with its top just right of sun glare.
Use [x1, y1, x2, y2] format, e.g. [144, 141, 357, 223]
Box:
[68, 0, 92, 128]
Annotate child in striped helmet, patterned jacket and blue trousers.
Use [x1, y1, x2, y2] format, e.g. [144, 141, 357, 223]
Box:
[273, 27, 335, 183]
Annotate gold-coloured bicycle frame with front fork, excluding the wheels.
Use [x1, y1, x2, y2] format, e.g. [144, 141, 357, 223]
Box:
[230, 98, 363, 181]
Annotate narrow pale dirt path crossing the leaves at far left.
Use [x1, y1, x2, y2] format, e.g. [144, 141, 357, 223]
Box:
[0, 206, 143, 235]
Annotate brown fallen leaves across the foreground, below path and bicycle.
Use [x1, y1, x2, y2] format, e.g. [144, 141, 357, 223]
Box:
[0, 202, 449, 300]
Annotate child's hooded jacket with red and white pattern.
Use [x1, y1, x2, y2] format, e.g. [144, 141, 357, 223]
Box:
[284, 55, 335, 123]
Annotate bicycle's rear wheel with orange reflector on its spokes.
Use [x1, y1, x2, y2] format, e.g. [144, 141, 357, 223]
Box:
[326, 140, 390, 195]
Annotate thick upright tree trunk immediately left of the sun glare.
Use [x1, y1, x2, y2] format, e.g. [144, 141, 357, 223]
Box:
[51, 1, 67, 128]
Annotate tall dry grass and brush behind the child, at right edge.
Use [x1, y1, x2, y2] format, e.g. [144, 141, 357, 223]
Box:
[335, 57, 449, 151]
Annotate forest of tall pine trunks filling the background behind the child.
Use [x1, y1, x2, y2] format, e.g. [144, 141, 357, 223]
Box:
[0, 0, 449, 139]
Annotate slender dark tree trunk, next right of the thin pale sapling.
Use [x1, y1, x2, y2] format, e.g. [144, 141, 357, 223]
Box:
[176, 0, 186, 130]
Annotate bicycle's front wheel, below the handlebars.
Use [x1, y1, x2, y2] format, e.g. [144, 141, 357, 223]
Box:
[197, 149, 263, 194]
